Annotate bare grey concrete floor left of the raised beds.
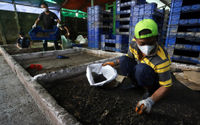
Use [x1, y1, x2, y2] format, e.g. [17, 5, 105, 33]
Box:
[0, 55, 49, 125]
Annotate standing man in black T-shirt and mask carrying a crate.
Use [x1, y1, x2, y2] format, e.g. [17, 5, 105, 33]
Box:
[32, 3, 60, 51]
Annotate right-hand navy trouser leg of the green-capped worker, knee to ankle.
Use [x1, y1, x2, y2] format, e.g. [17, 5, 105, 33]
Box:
[135, 63, 159, 96]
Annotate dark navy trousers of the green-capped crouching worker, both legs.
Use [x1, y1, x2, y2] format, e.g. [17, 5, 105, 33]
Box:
[120, 56, 159, 90]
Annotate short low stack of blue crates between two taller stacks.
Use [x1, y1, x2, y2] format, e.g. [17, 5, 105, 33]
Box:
[101, 35, 128, 53]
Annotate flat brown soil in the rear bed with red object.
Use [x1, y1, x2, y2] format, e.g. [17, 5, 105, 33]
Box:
[19, 53, 103, 76]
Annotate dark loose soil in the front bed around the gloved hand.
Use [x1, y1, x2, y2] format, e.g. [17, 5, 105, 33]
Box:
[41, 74, 200, 125]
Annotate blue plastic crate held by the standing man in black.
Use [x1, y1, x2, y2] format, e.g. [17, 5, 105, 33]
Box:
[29, 26, 59, 41]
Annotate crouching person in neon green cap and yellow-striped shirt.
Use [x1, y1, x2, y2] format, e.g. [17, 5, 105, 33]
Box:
[103, 19, 172, 114]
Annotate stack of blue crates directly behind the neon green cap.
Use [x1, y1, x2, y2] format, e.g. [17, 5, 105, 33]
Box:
[129, 3, 164, 41]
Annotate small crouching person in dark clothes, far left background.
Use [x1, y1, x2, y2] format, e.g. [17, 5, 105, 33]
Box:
[17, 32, 30, 49]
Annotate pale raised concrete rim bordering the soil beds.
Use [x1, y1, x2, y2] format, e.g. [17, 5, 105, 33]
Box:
[0, 47, 123, 125]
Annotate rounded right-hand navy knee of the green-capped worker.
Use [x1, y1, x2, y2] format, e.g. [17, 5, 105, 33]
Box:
[135, 63, 156, 86]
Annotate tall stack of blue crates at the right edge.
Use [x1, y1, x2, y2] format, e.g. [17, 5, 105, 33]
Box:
[165, 0, 200, 64]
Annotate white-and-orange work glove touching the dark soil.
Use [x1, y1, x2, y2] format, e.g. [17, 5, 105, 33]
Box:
[135, 97, 154, 114]
